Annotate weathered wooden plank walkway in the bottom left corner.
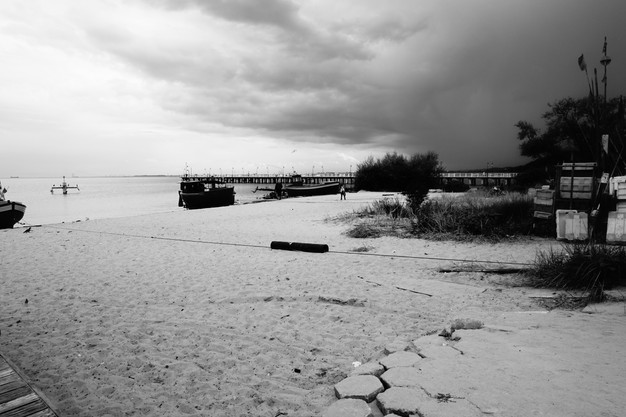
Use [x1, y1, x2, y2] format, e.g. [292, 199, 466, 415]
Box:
[0, 353, 58, 417]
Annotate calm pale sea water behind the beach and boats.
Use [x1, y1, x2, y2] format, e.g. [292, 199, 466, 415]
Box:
[2, 177, 264, 225]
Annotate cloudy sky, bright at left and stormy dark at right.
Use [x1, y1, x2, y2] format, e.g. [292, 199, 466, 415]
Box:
[0, 0, 626, 178]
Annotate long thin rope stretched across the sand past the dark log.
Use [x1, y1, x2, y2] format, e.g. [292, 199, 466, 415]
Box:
[41, 225, 533, 266]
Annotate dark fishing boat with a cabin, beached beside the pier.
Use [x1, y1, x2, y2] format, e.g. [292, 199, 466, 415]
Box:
[178, 174, 235, 209]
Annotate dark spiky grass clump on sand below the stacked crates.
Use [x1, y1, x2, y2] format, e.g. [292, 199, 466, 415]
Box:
[530, 243, 626, 301]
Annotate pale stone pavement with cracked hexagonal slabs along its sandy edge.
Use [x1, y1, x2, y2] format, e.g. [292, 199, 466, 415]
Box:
[323, 302, 626, 417]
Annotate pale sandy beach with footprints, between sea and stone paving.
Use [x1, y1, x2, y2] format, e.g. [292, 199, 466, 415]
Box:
[0, 193, 624, 417]
